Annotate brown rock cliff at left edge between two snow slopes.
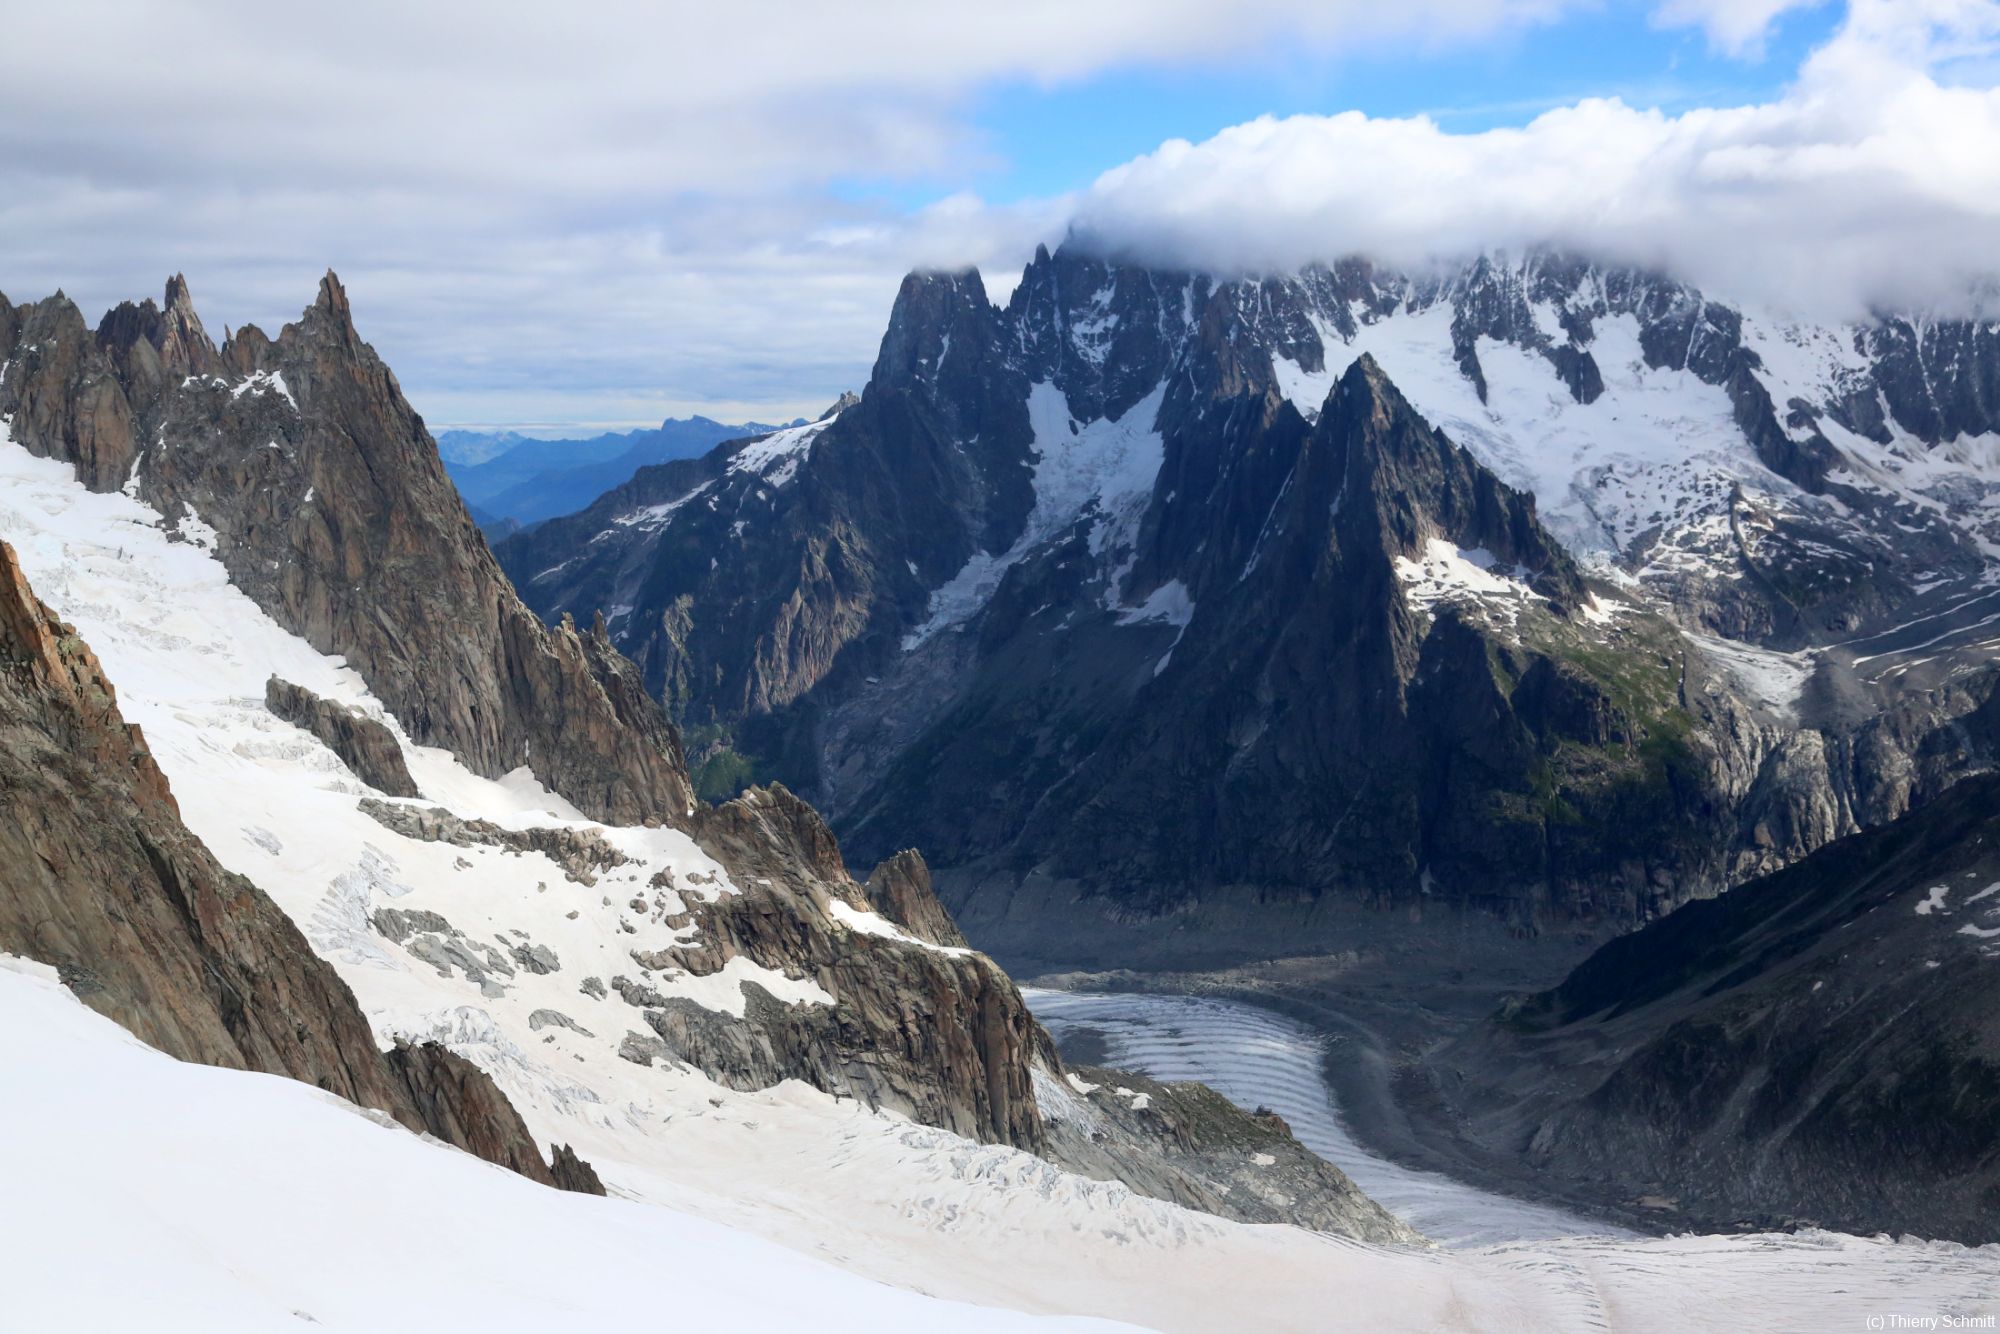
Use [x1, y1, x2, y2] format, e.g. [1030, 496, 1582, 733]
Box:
[0, 542, 592, 1184]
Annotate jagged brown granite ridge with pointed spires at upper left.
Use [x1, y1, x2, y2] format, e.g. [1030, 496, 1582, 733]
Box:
[0, 274, 692, 824]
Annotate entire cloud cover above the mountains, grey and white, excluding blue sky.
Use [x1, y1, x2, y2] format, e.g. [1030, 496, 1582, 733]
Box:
[0, 0, 2000, 424]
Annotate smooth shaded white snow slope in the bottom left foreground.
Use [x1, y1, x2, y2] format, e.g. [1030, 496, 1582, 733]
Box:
[0, 956, 1114, 1334]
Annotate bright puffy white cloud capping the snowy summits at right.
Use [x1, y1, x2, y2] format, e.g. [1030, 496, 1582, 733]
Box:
[1078, 0, 2000, 316]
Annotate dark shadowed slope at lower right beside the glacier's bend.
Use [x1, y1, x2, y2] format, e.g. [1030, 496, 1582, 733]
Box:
[1414, 776, 2000, 1242]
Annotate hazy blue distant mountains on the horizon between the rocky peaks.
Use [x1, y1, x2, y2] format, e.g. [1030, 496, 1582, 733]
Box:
[438, 416, 804, 536]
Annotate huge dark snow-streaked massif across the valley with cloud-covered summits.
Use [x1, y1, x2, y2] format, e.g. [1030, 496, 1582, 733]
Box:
[500, 248, 2000, 962]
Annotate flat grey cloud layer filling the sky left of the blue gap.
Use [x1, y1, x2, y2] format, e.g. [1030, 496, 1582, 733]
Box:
[0, 0, 1582, 422]
